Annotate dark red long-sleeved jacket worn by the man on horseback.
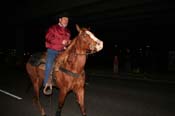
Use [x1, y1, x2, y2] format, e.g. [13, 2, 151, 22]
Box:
[45, 24, 70, 50]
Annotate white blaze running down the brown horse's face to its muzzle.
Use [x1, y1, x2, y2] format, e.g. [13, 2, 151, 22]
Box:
[86, 31, 103, 51]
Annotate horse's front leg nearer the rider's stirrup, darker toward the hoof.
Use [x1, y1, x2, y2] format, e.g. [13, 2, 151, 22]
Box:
[56, 89, 67, 116]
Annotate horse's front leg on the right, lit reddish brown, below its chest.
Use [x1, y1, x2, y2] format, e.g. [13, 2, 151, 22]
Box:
[75, 87, 86, 116]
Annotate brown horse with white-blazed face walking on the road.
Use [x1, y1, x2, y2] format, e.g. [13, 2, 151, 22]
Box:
[26, 25, 103, 116]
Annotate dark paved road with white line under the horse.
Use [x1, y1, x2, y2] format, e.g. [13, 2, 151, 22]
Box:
[0, 67, 175, 116]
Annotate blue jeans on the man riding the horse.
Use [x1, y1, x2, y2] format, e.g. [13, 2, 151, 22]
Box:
[44, 49, 59, 86]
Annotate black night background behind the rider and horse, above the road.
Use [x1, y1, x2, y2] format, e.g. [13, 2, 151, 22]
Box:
[0, 0, 175, 76]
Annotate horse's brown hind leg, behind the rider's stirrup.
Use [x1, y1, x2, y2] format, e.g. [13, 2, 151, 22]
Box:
[33, 79, 46, 116]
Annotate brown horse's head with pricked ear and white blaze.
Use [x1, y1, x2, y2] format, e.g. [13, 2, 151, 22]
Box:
[76, 25, 103, 53]
